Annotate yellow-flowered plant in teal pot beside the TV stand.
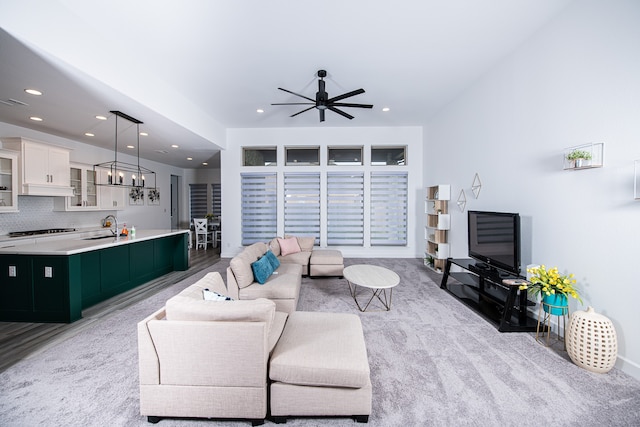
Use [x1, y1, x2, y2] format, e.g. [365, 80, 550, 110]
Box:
[520, 265, 582, 315]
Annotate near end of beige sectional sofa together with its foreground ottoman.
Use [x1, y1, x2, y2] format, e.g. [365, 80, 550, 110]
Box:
[138, 273, 372, 425]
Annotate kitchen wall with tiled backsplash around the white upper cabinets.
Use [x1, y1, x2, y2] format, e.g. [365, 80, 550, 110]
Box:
[0, 122, 220, 234]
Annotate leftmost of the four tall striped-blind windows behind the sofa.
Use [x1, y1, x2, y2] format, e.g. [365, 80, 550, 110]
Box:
[240, 173, 278, 245]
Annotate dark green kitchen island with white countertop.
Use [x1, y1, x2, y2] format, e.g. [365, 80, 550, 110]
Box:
[0, 230, 189, 323]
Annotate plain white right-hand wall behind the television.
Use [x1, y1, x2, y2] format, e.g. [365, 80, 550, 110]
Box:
[425, 0, 640, 378]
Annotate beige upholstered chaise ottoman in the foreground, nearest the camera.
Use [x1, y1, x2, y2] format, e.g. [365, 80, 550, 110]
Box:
[269, 311, 372, 423]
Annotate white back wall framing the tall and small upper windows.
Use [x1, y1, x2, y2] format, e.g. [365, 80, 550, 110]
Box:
[221, 127, 424, 258]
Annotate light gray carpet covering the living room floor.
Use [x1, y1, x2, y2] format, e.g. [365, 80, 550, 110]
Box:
[0, 259, 640, 427]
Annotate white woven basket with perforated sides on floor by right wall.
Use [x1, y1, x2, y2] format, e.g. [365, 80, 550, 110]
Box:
[566, 307, 618, 373]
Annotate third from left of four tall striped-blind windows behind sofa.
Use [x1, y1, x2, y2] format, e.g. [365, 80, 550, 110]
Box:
[327, 172, 364, 246]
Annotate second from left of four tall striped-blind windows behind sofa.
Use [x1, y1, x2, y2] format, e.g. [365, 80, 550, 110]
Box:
[284, 173, 320, 243]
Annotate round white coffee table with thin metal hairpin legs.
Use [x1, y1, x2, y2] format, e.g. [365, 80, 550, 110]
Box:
[342, 264, 400, 311]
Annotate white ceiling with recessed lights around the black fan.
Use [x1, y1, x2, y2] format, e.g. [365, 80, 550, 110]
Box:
[0, 0, 571, 168]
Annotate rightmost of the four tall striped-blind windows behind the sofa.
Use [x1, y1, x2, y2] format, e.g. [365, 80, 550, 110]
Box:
[370, 172, 408, 246]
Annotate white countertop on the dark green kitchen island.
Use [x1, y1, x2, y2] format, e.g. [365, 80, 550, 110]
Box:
[0, 229, 189, 255]
